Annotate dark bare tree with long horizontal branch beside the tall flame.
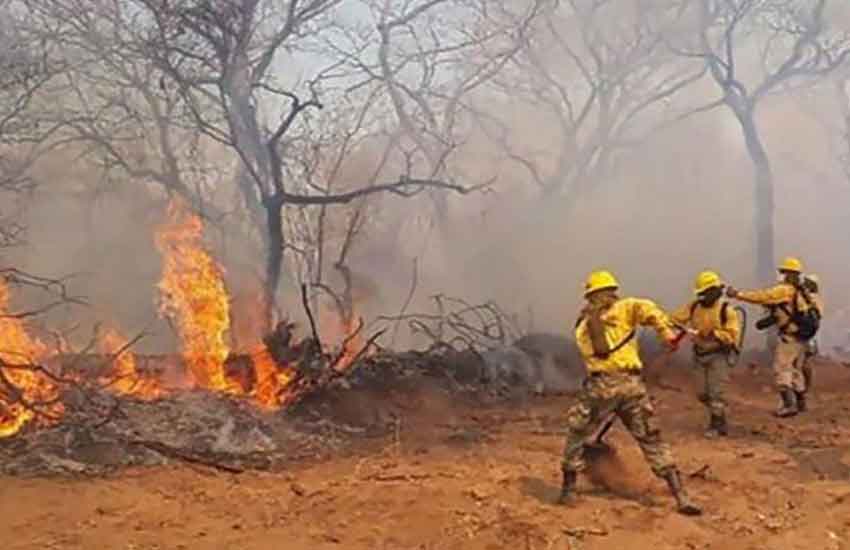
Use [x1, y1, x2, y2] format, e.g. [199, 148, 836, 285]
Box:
[124, 0, 476, 330]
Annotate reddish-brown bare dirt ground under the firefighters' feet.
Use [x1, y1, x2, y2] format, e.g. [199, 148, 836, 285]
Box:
[0, 364, 850, 550]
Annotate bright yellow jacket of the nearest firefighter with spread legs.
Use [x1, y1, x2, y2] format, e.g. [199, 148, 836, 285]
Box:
[575, 298, 676, 372]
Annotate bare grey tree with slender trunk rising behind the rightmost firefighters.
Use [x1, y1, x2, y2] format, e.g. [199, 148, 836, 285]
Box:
[677, 0, 850, 279]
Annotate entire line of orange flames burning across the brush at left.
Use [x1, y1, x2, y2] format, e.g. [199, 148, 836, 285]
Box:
[0, 202, 363, 438]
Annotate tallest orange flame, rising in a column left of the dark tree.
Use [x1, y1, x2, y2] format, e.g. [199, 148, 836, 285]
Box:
[156, 202, 239, 393]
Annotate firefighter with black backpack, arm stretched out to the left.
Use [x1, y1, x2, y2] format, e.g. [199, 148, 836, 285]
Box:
[726, 258, 820, 418]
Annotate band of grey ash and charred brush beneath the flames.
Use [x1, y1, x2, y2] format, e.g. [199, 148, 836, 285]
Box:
[0, 338, 584, 475]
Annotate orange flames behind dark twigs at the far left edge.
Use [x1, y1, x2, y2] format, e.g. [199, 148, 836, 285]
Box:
[0, 279, 63, 438]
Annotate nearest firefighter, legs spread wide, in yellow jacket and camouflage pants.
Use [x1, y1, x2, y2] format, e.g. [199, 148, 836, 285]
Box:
[559, 271, 702, 515]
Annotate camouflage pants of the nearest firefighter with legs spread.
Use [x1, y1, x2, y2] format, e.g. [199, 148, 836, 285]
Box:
[563, 373, 674, 477]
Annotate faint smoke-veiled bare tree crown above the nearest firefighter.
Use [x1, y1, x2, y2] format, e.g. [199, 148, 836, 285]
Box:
[474, 0, 705, 212]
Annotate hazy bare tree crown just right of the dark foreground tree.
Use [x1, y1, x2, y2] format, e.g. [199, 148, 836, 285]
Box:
[337, 0, 540, 228]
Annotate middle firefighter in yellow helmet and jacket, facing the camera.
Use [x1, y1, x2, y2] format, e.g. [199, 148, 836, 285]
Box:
[672, 271, 741, 438]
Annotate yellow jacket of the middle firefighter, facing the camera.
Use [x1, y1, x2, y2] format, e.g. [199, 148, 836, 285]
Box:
[671, 300, 741, 353]
